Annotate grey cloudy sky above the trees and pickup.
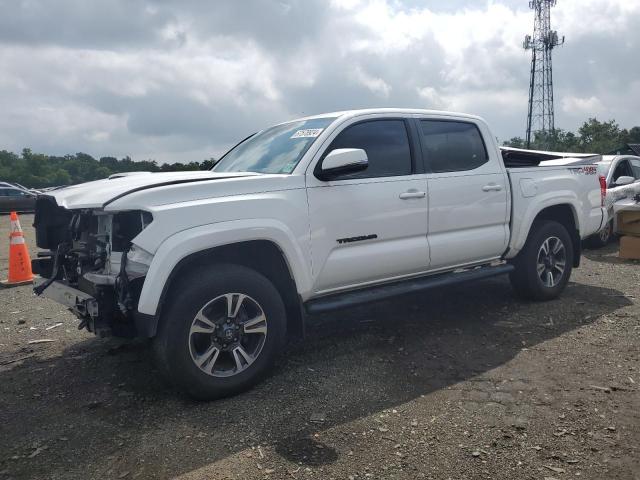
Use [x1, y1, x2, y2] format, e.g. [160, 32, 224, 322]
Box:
[0, 0, 640, 162]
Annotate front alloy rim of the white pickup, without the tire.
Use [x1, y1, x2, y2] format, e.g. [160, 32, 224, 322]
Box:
[189, 293, 267, 377]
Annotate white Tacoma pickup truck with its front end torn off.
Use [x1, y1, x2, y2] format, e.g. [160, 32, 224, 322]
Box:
[33, 109, 607, 398]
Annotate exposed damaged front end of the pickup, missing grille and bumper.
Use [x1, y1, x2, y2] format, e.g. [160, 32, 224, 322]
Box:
[32, 196, 153, 337]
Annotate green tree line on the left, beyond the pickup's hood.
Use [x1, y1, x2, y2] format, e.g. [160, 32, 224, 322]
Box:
[0, 148, 216, 188]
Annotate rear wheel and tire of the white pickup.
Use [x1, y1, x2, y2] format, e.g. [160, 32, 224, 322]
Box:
[509, 220, 573, 301]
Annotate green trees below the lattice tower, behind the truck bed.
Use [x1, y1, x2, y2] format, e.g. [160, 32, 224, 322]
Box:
[504, 118, 640, 154]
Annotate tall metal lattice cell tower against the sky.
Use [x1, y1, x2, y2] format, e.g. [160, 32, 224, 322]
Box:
[524, 0, 564, 148]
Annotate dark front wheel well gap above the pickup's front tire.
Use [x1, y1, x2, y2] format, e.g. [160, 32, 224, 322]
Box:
[156, 240, 304, 338]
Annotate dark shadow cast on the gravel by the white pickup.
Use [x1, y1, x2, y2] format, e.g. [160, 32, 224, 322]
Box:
[0, 279, 631, 478]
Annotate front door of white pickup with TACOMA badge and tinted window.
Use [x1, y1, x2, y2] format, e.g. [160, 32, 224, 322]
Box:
[307, 118, 429, 294]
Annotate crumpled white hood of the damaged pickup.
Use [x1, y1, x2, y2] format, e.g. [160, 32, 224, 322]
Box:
[43, 171, 260, 209]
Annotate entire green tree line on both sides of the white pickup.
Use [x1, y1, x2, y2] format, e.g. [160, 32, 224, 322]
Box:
[0, 118, 640, 188]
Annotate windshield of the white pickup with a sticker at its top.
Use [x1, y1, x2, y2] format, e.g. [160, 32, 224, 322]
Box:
[213, 117, 336, 173]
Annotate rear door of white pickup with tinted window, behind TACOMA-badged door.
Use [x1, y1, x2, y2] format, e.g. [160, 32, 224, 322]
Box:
[417, 118, 509, 270]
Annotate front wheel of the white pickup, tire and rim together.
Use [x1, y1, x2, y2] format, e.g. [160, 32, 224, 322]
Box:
[154, 265, 287, 400]
